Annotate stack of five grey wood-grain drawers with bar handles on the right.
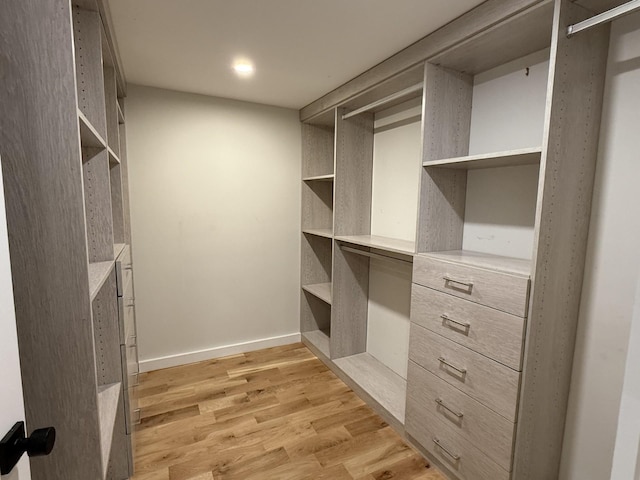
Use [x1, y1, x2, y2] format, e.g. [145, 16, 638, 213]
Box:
[406, 254, 530, 480]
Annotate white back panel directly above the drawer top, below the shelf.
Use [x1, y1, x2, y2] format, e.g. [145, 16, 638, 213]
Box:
[462, 165, 539, 258]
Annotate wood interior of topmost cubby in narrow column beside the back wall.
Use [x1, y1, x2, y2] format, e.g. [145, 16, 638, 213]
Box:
[302, 123, 335, 178]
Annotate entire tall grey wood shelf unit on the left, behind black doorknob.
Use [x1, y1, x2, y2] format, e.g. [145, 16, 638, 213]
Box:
[0, 0, 137, 480]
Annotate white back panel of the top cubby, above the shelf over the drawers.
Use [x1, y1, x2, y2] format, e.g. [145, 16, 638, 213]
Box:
[469, 50, 549, 155]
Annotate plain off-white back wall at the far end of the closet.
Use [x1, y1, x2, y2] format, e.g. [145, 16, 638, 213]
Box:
[126, 86, 301, 369]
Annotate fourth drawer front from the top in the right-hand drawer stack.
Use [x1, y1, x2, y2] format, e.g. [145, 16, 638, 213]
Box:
[407, 362, 515, 470]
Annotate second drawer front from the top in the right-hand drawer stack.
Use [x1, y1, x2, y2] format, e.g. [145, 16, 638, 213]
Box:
[411, 283, 525, 370]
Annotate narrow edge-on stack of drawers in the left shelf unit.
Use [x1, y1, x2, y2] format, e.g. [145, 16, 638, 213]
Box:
[116, 245, 140, 474]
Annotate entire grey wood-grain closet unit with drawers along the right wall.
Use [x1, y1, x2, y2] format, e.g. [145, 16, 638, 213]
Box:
[300, 0, 609, 480]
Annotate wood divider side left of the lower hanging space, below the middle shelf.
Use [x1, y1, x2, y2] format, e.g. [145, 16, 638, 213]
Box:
[331, 238, 369, 359]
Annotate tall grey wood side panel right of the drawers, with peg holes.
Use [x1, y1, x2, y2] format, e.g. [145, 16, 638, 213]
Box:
[514, 1, 609, 480]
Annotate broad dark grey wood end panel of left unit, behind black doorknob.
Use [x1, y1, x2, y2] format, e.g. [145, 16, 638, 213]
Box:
[0, 0, 102, 479]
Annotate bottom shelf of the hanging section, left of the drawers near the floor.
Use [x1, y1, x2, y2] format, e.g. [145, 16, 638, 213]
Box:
[333, 352, 407, 423]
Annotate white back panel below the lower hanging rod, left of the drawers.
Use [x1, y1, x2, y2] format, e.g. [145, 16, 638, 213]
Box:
[367, 259, 411, 379]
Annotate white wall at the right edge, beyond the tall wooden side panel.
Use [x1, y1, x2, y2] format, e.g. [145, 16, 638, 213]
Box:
[561, 14, 640, 480]
